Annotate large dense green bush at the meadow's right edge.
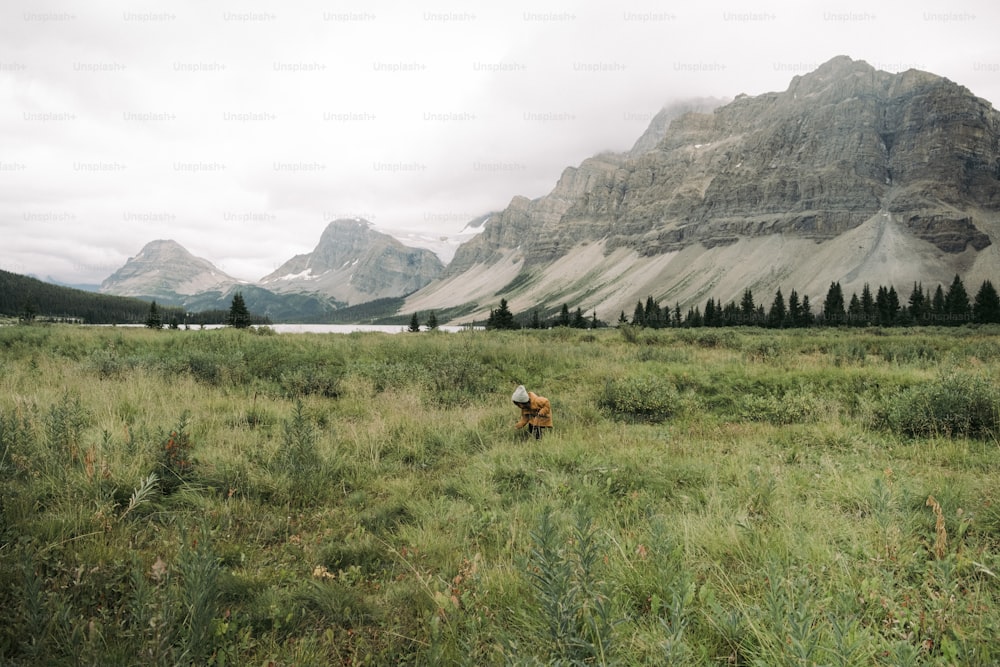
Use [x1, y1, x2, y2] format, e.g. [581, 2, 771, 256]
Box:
[876, 373, 1000, 439]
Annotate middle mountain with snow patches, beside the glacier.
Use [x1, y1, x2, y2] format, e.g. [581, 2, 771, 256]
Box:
[259, 219, 444, 304]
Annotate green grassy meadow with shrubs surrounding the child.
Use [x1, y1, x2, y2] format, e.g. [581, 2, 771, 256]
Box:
[0, 326, 1000, 667]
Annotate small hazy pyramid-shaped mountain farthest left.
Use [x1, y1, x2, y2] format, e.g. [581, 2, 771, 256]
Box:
[99, 240, 240, 306]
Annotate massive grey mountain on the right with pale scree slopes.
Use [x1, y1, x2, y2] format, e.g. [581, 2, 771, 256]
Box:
[402, 56, 1000, 320]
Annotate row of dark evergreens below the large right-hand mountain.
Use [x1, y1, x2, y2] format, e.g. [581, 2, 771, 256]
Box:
[486, 275, 1000, 329]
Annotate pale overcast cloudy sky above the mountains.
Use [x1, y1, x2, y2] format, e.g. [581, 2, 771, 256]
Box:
[0, 0, 1000, 283]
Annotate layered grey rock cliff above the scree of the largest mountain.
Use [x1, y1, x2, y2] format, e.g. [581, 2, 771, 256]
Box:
[548, 57, 1000, 262]
